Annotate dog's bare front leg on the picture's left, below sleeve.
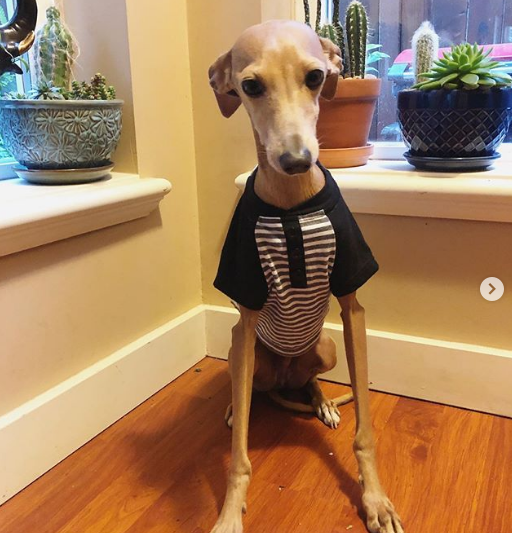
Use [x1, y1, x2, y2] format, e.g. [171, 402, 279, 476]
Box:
[212, 307, 259, 533]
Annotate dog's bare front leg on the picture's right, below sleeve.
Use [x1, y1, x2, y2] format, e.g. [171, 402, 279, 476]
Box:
[338, 292, 403, 533]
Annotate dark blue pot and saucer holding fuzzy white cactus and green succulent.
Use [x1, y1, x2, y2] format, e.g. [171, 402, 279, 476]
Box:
[398, 24, 512, 171]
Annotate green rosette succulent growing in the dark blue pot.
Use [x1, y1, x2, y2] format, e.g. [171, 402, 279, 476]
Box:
[412, 43, 512, 91]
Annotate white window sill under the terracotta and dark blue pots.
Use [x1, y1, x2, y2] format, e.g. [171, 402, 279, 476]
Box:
[236, 160, 512, 222]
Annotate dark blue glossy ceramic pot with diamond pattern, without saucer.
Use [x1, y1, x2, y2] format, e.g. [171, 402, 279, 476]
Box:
[398, 87, 512, 158]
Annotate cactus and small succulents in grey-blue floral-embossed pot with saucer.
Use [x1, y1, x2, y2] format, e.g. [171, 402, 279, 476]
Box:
[0, 7, 123, 183]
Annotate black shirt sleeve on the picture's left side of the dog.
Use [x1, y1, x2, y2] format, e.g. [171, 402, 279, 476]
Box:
[213, 198, 268, 310]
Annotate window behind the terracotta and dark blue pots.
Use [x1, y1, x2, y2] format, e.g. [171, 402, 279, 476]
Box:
[294, 0, 512, 148]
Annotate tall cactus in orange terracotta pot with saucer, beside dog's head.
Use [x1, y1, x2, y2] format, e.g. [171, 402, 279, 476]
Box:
[304, 0, 389, 168]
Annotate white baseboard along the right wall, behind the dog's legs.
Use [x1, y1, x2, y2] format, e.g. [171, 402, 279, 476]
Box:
[205, 306, 512, 417]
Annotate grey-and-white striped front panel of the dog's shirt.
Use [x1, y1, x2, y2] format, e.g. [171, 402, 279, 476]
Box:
[255, 211, 336, 357]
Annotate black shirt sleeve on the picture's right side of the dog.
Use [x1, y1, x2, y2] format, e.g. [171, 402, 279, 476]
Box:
[328, 198, 379, 298]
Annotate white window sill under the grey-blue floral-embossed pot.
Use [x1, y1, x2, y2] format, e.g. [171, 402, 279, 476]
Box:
[0, 172, 171, 257]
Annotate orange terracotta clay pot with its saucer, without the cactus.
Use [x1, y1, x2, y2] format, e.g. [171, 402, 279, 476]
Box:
[317, 78, 381, 168]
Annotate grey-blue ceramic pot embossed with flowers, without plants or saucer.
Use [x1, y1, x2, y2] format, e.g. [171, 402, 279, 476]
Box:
[0, 100, 123, 169]
